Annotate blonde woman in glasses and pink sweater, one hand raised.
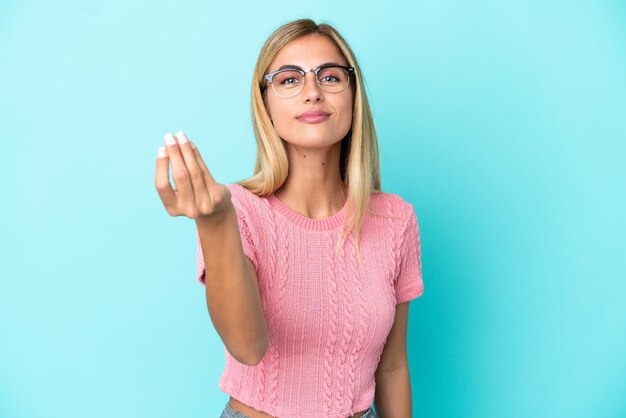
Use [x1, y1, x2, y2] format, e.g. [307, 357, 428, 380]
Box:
[155, 19, 423, 418]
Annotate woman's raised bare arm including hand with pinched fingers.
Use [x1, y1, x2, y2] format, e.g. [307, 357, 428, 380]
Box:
[155, 132, 268, 365]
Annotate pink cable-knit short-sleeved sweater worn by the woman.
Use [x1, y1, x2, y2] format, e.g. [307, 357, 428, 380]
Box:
[196, 184, 424, 418]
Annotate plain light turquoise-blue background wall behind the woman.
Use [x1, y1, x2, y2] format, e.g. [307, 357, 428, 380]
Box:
[0, 0, 626, 418]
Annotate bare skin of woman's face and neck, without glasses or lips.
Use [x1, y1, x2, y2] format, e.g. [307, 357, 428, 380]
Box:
[265, 34, 353, 219]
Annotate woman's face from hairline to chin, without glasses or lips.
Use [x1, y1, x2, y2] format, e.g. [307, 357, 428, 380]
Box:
[265, 34, 354, 148]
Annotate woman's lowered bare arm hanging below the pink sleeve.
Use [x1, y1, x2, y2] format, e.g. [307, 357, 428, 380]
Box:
[374, 302, 412, 418]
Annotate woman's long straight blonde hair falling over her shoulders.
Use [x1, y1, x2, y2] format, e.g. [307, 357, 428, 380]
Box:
[237, 19, 381, 263]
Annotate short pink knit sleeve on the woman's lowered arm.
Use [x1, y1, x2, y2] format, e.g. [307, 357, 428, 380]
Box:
[395, 205, 424, 304]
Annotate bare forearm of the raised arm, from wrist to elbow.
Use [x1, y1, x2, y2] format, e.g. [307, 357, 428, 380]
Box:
[196, 207, 267, 365]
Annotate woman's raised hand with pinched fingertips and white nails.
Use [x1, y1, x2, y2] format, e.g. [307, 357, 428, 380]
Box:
[154, 131, 232, 220]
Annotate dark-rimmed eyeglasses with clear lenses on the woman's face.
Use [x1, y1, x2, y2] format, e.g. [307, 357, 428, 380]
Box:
[263, 64, 354, 97]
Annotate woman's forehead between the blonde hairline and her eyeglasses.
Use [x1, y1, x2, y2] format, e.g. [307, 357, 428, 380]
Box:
[268, 34, 348, 72]
